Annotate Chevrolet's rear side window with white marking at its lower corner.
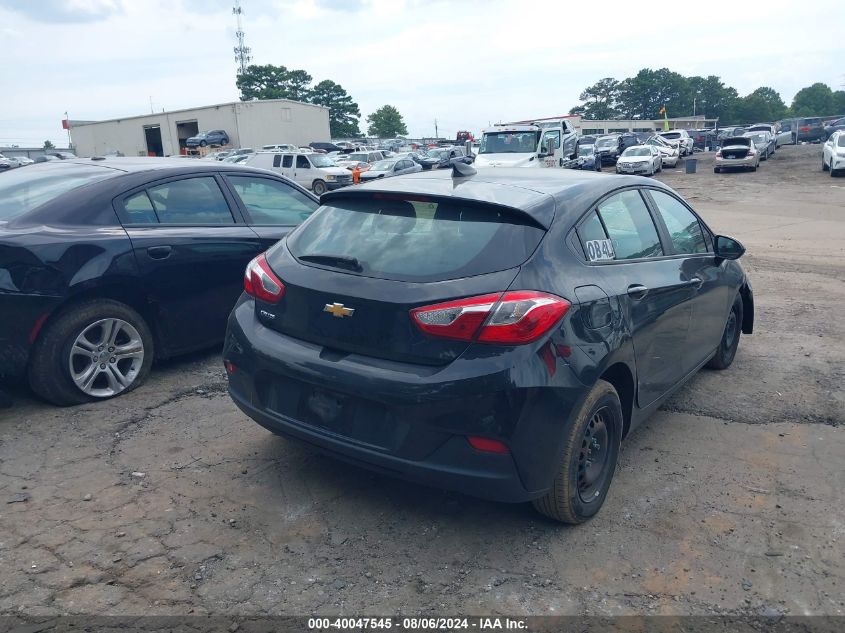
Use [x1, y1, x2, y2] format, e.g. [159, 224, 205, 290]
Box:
[578, 190, 663, 260]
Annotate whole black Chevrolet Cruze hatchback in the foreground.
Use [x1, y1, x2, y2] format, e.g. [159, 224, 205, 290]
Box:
[224, 168, 754, 523]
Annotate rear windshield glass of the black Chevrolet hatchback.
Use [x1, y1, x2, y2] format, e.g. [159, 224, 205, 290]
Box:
[288, 198, 545, 282]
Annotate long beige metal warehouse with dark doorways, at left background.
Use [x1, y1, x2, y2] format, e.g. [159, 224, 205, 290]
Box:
[69, 99, 330, 156]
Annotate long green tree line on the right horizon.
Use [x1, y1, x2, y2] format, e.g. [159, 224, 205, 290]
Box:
[569, 68, 845, 123]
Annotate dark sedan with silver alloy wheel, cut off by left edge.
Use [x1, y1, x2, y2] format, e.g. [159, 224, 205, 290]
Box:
[0, 158, 318, 405]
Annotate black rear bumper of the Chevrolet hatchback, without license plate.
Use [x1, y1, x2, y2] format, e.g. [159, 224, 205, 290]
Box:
[223, 300, 586, 502]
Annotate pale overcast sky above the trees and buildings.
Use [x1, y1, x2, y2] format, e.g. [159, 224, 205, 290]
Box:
[0, 0, 845, 146]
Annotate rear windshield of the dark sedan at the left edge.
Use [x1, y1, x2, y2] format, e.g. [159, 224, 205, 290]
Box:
[0, 163, 113, 220]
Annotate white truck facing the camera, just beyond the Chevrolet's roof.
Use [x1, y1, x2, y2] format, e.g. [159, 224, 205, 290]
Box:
[474, 119, 578, 167]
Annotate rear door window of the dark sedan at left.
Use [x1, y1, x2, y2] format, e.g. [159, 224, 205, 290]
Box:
[147, 176, 235, 224]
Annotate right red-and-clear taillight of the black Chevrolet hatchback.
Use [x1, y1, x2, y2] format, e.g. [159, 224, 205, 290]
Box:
[411, 290, 570, 345]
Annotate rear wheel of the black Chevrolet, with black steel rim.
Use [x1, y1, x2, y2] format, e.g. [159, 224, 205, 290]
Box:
[532, 380, 623, 523]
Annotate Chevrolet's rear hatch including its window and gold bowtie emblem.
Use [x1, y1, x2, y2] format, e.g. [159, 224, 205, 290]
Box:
[264, 193, 545, 365]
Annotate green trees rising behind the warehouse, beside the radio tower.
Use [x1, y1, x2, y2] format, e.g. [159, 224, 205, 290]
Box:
[235, 64, 408, 138]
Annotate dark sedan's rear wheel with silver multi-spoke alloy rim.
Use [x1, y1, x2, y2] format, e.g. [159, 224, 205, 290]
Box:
[29, 299, 155, 406]
